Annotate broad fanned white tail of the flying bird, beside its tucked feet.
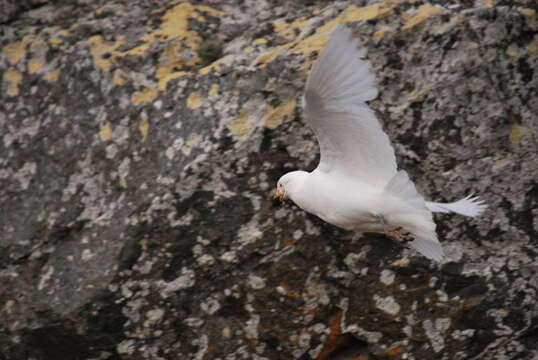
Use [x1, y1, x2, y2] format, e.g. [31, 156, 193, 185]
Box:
[385, 171, 444, 261]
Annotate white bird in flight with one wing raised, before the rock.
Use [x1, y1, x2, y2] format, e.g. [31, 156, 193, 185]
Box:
[275, 27, 486, 261]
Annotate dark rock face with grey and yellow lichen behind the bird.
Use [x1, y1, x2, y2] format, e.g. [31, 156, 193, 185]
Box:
[0, 0, 538, 360]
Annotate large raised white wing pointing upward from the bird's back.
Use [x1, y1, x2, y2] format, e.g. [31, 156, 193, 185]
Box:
[304, 26, 396, 187]
